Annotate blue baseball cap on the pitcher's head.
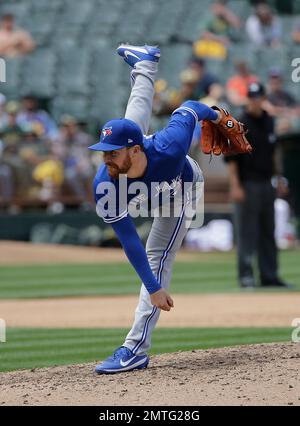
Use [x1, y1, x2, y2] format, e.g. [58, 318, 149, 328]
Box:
[89, 118, 143, 151]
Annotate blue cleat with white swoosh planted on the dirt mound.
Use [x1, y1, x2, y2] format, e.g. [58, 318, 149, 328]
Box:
[95, 346, 149, 374]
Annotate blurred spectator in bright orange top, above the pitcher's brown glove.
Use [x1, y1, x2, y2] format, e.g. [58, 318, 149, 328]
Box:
[226, 60, 258, 106]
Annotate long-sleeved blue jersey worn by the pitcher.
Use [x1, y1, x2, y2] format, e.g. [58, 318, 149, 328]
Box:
[94, 101, 217, 293]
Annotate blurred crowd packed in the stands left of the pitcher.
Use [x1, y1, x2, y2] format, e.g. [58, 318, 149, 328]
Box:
[0, 95, 98, 205]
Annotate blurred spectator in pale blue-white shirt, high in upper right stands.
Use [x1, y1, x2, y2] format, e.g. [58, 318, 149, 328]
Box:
[246, 3, 282, 47]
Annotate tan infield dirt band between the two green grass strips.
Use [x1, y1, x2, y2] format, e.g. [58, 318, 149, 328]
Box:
[0, 293, 300, 328]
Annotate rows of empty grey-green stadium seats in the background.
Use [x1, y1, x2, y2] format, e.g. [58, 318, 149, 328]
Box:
[0, 0, 300, 125]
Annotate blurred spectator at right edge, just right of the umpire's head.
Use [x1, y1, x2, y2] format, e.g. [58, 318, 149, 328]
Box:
[264, 68, 300, 134]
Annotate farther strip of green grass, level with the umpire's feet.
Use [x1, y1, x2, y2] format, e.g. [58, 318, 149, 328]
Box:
[0, 251, 300, 299]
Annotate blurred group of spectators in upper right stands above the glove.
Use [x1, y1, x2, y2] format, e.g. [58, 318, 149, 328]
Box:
[154, 0, 300, 135]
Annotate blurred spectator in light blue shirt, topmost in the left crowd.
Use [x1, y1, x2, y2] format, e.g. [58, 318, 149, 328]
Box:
[17, 95, 58, 139]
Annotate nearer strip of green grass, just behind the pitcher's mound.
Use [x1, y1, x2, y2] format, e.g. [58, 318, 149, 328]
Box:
[0, 328, 291, 371]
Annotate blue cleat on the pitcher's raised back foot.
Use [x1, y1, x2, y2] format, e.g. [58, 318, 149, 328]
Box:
[117, 44, 160, 67]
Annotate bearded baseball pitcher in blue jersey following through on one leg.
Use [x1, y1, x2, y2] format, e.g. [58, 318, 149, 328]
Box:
[90, 44, 251, 374]
